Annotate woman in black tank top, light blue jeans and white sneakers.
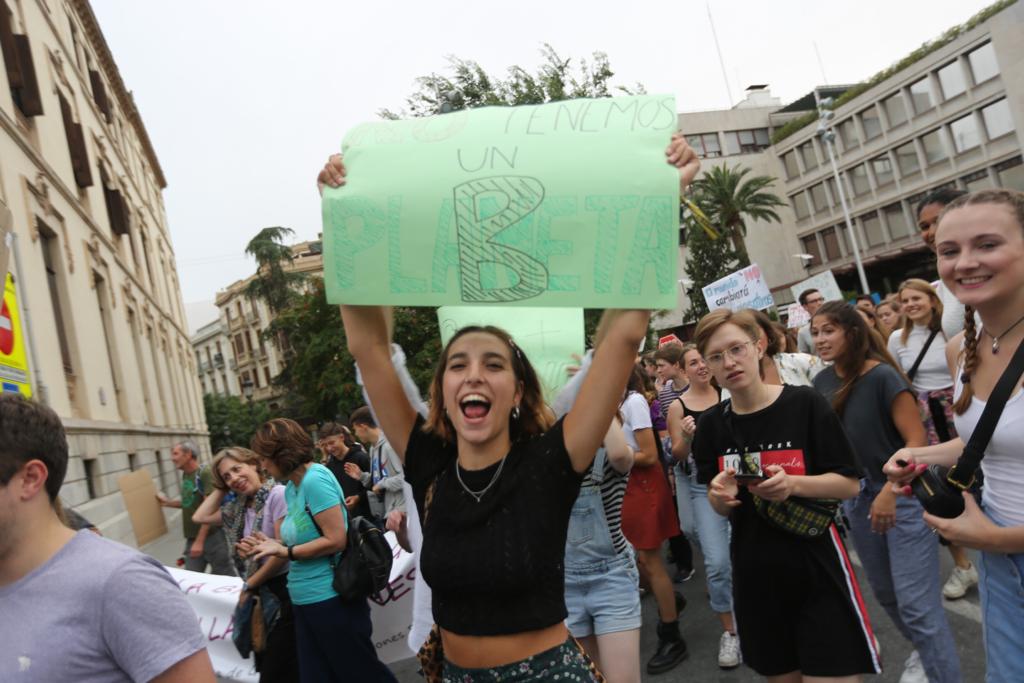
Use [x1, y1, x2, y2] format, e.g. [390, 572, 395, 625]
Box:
[669, 344, 739, 669]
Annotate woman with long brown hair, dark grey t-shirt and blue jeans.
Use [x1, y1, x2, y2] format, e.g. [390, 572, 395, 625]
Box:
[811, 299, 961, 682]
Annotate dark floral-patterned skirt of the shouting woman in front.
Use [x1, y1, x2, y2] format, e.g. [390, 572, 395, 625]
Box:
[441, 637, 604, 683]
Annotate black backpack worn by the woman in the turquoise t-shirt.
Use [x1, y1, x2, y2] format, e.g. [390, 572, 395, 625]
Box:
[306, 505, 394, 600]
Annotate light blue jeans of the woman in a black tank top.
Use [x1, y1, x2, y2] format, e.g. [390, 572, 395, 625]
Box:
[672, 465, 732, 614]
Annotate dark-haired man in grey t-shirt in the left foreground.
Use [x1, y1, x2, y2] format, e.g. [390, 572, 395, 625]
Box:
[0, 393, 215, 683]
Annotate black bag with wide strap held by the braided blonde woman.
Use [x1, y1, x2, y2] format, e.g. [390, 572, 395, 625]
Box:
[898, 335, 1024, 519]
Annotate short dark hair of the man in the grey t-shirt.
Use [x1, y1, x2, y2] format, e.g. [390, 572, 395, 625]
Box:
[0, 392, 68, 504]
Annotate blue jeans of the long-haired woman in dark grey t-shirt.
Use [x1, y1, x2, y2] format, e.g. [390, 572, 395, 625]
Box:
[843, 479, 963, 683]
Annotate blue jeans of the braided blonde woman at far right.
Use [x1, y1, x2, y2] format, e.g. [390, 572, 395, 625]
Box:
[978, 510, 1024, 683]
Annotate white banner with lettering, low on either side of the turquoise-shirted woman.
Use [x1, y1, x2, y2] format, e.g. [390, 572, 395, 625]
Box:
[165, 531, 416, 683]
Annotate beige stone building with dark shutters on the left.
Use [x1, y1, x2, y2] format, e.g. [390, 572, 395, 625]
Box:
[0, 0, 209, 543]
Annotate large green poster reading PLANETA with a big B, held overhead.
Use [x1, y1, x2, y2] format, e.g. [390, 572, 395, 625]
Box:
[323, 95, 679, 308]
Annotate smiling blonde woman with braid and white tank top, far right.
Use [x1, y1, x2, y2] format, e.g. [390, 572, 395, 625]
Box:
[885, 189, 1024, 681]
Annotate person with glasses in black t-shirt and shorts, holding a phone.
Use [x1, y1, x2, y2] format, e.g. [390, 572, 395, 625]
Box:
[692, 309, 881, 680]
